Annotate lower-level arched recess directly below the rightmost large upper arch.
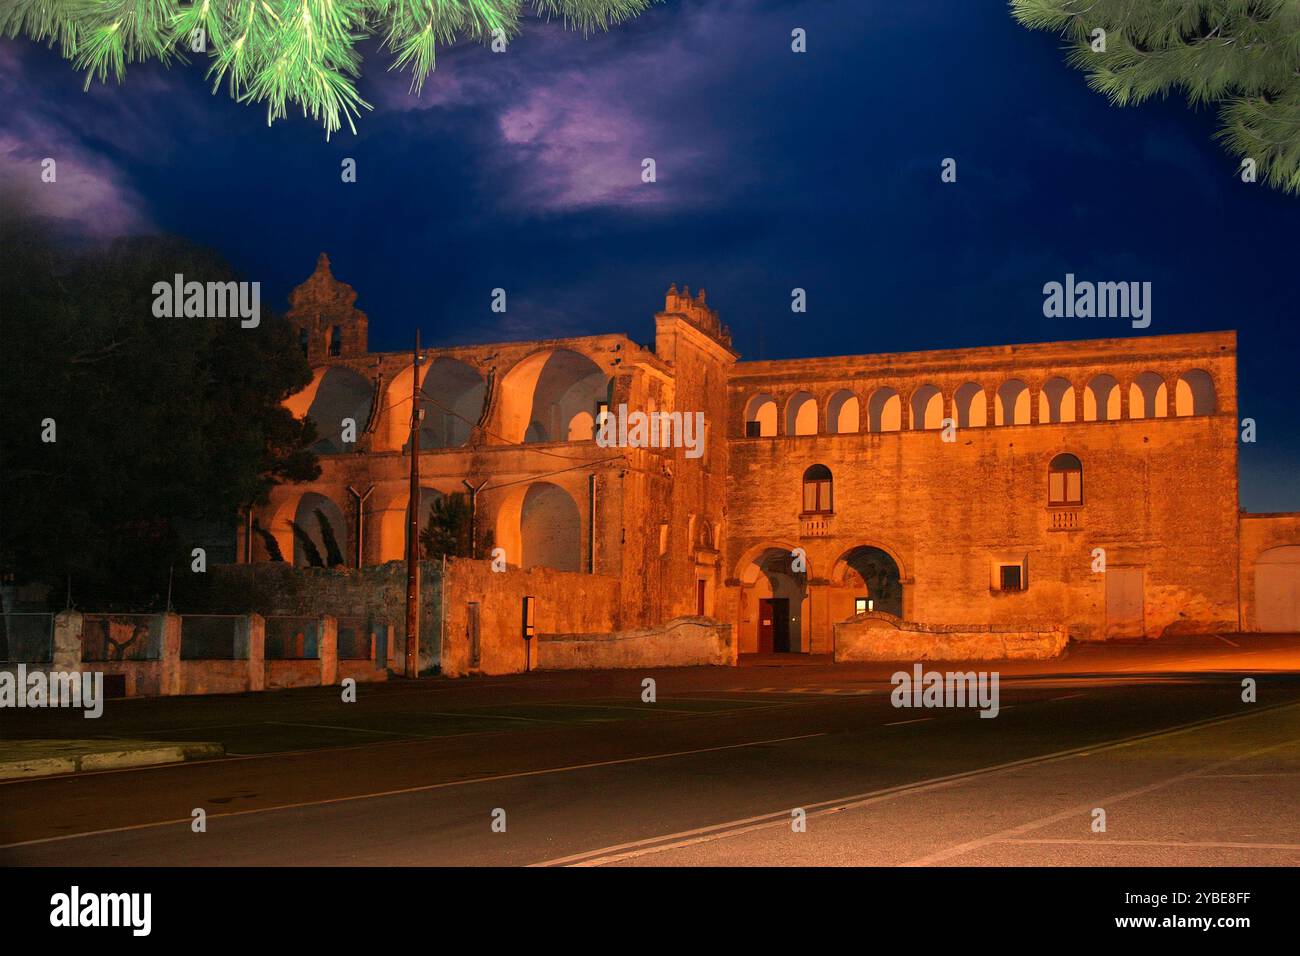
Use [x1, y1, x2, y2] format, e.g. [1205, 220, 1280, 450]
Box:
[494, 481, 584, 571]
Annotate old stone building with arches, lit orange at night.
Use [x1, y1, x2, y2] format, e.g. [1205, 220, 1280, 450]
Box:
[241, 255, 1300, 663]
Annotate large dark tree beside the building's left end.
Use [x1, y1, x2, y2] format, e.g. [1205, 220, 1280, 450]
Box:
[0, 208, 320, 609]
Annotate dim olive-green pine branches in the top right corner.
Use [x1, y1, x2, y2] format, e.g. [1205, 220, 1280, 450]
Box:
[1011, 0, 1300, 193]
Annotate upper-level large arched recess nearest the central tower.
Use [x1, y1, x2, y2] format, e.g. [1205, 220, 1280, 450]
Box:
[499, 349, 612, 442]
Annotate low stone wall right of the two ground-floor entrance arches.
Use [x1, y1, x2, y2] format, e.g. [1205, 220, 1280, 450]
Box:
[835, 611, 1069, 661]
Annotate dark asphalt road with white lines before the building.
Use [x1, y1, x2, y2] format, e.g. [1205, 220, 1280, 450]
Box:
[0, 636, 1300, 866]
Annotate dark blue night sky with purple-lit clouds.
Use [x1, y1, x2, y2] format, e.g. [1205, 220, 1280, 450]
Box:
[0, 0, 1300, 511]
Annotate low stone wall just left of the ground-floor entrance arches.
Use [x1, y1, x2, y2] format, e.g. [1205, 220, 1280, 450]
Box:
[537, 618, 737, 670]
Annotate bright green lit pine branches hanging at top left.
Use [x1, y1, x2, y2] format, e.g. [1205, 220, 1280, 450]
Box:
[0, 0, 655, 135]
